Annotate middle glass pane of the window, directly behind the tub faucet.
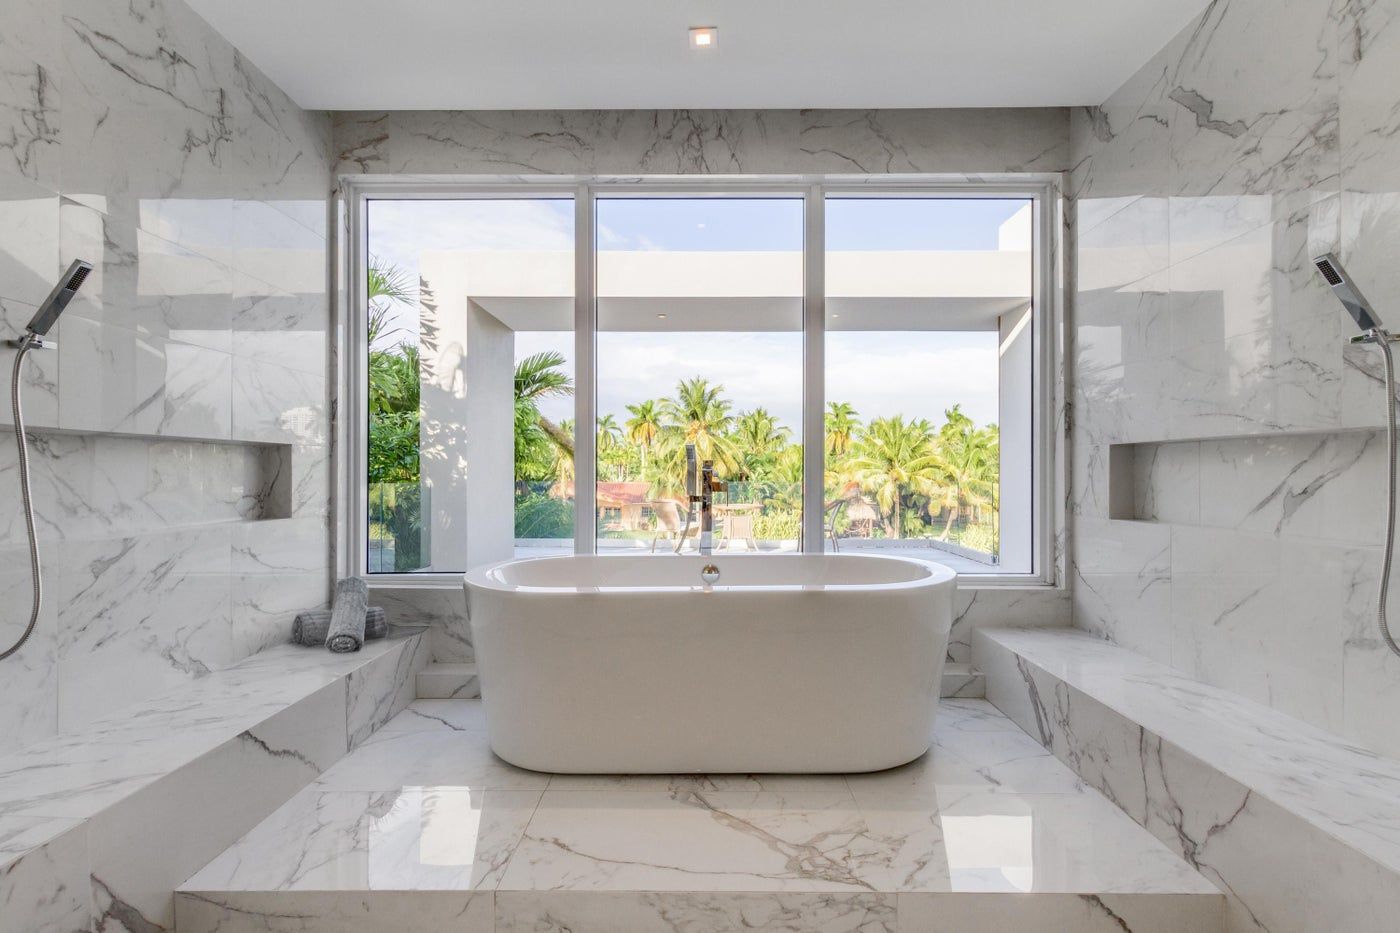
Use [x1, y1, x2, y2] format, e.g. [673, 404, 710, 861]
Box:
[596, 198, 802, 553]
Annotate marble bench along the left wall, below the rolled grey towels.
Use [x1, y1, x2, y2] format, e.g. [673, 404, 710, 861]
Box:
[0, 633, 427, 933]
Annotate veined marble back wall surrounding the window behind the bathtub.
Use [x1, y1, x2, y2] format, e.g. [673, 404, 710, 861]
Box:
[333, 108, 1070, 652]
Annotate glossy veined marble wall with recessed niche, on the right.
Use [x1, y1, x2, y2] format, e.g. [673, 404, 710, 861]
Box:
[1071, 0, 1400, 754]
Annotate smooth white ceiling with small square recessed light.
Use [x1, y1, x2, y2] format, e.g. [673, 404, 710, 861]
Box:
[189, 0, 1205, 111]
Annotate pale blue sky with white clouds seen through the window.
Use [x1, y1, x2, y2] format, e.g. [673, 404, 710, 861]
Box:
[370, 198, 1025, 431]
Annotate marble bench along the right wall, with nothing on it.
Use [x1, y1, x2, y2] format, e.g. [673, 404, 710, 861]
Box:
[973, 629, 1400, 933]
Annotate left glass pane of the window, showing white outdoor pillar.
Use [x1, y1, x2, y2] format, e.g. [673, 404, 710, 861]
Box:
[365, 198, 574, 573]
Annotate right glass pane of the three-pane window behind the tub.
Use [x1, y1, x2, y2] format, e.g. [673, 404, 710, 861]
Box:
[823, 196, 1033, 573]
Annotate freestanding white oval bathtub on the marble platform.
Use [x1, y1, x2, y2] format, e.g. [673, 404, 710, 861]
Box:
[465, 555, 956, 773]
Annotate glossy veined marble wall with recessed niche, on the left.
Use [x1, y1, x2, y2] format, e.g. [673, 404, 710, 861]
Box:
[0, 0, 330, 748]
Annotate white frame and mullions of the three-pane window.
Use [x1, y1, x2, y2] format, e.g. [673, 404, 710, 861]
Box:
[335, 175, 1063, 588]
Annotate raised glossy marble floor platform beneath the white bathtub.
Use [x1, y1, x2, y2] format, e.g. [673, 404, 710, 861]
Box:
[178, 700, 1222, 933]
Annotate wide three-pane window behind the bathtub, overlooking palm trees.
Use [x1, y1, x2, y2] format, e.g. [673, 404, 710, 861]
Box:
[347, 182, 1046, 580]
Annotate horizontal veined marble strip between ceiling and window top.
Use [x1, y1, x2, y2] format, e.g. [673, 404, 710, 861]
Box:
[335, 109, 1068, 175]
